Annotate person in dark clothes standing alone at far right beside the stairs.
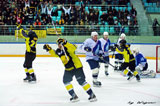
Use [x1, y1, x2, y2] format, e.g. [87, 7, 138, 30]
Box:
[152, 18, 160, 36]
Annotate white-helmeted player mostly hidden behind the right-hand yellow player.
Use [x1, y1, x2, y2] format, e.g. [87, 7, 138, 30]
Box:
[114, 33, 126, 71]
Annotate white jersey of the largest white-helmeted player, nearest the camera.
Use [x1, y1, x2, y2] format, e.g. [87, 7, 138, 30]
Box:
[81, 38, 99, 60]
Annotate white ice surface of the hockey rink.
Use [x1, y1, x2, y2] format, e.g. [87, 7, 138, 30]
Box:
[0, 57, 160, 106]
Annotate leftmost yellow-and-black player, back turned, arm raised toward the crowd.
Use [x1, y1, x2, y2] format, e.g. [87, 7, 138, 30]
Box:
[17, 24, 38, 83]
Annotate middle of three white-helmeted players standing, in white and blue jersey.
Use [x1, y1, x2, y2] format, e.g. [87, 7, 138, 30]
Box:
[99, 32, 111, 76]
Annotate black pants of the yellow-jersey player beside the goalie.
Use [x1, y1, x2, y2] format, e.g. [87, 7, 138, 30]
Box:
[120, 60, 136, 72]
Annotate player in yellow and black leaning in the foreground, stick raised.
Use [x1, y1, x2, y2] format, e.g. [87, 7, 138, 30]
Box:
[43, 38, 97, 102]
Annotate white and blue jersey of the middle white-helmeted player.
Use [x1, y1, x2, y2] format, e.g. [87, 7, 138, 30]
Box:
[99, 38, 111, 56]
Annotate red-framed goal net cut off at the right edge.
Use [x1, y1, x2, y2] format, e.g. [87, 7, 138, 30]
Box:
[156, 46, 160, 73]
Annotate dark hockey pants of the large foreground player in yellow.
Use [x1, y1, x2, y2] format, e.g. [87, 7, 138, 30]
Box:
[63, 68, 85, 85]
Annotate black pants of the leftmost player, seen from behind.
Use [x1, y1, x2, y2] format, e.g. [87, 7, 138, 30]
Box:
[23, 52, 36, 69]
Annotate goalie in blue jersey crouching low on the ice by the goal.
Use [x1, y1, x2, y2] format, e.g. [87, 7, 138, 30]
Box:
[133, 48, 156, 78]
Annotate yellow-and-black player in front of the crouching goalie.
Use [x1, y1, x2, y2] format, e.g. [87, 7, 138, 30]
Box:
[112, 40, 140, 81]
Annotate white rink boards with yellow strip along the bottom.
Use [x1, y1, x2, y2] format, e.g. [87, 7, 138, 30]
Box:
[0, 43, 157, 59]
